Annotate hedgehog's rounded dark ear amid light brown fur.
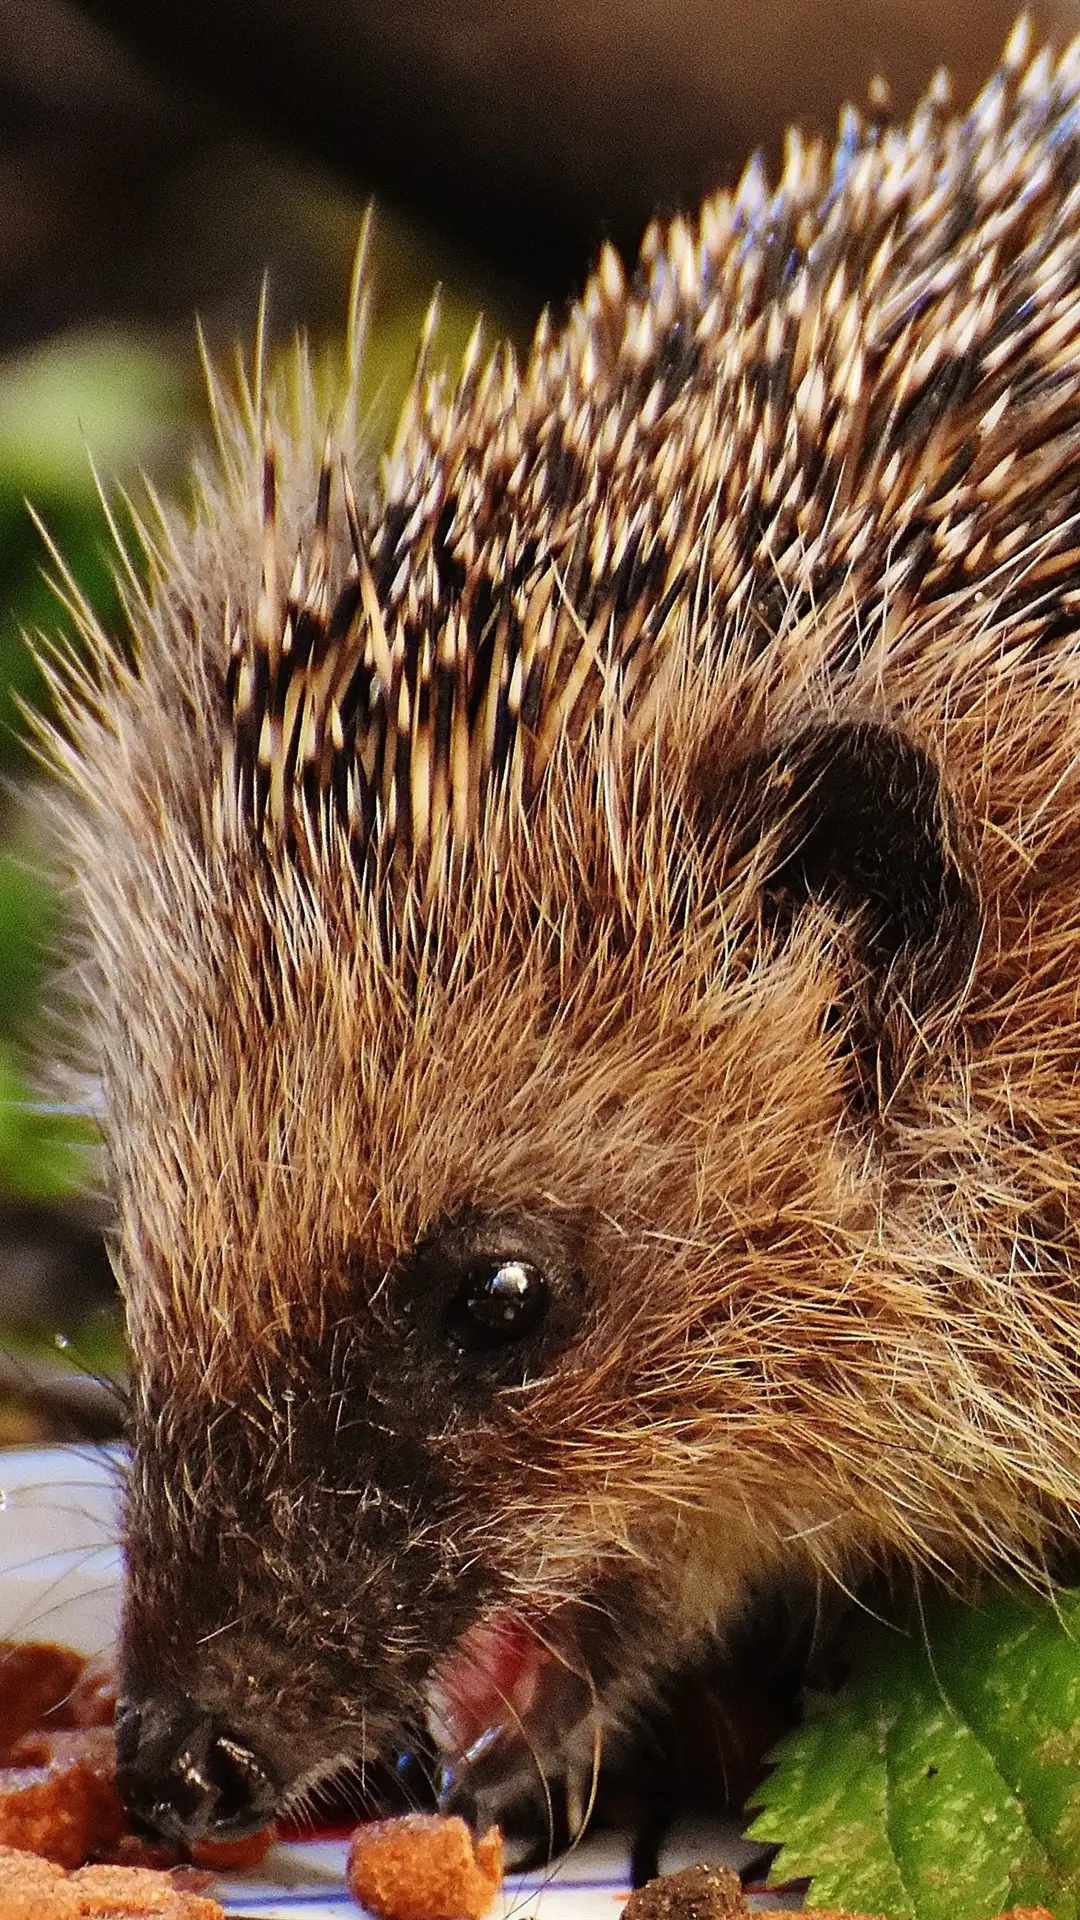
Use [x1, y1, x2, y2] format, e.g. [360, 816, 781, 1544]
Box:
[709, 720, 982, 1085]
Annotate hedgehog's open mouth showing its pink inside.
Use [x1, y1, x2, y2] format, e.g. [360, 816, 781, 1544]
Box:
[429, 1605, 596, 1851]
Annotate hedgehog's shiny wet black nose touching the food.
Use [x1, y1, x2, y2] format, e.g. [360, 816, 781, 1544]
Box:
[115, 1693, 281, 1841]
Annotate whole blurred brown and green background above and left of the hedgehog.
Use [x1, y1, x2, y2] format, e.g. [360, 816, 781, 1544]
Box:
[0, 0, 1080, 1442]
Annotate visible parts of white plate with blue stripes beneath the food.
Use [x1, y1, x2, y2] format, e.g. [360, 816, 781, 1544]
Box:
[0, 1448, 778, 1920]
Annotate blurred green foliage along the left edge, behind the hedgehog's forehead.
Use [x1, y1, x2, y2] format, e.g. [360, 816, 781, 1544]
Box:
[0, 338, 184, 1221]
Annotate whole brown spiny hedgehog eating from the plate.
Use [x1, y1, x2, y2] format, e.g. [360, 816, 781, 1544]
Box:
[52, 23, 1080, 1866]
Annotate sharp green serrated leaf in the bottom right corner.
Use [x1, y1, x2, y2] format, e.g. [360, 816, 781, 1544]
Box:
[749, 1592, 1080, 1920]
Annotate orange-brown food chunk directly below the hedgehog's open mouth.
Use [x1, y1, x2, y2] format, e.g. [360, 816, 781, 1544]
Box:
[348, 1814, 502, 1920]
